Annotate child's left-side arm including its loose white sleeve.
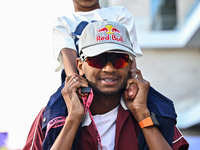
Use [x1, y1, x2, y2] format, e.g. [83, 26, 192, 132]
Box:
[52, 16, 77, 76]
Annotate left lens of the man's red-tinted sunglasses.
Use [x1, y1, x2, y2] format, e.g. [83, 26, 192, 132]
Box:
[87, 54, 106, 69]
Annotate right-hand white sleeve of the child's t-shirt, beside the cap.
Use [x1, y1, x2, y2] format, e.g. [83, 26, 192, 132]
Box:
[116, 6, 143, 56]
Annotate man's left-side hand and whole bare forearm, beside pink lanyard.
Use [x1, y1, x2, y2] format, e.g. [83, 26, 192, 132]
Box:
[51, 73, 88, 150]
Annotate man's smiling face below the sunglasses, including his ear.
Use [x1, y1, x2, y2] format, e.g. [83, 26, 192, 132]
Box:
[78, 54, 135, 96]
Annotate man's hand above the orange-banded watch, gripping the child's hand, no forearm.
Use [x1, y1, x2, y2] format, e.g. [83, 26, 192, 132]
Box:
[124, 69, 150, 122]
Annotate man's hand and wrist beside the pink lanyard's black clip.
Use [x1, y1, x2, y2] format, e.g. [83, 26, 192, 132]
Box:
[61, 74, 88, 119]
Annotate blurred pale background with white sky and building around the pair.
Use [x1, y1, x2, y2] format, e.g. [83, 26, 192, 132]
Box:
[0, 0, 200, 150]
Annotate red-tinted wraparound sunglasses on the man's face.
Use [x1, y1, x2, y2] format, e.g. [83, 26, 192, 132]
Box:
[85, 53, 131, 69]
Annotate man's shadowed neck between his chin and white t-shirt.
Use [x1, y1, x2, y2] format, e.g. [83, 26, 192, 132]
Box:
[90, 93, 121, 115]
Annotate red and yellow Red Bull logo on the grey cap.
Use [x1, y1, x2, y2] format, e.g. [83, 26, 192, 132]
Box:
[96, 25, 123, 42]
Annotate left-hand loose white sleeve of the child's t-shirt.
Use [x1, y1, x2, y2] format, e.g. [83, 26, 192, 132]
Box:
[53, 17, 76, 71]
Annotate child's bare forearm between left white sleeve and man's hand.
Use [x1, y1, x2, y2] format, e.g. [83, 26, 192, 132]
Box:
[61, 48, 78, 76]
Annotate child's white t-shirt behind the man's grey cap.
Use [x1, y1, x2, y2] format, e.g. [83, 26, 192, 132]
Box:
[53, 6, 142, 71]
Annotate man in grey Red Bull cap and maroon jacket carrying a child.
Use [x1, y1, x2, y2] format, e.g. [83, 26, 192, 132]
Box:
[24, 21, 188, 150]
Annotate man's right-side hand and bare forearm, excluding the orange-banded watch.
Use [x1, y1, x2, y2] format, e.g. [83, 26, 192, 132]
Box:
[124, 69, 171, 150]
